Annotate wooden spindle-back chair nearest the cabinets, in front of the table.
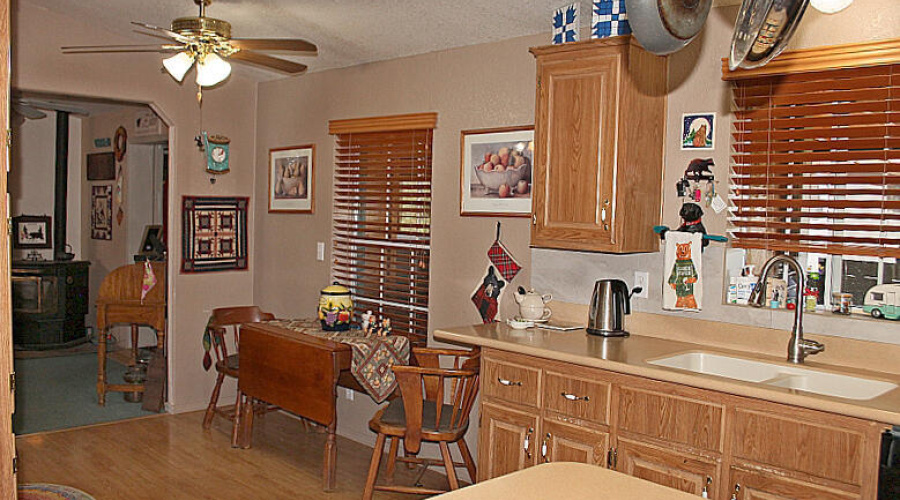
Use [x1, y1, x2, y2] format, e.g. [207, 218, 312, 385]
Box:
[363, 347, 480, 500]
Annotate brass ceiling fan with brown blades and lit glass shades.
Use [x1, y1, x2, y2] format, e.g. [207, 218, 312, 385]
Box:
[62, 0, 317, 87]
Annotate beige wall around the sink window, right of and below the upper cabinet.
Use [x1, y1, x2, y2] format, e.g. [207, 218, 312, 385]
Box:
[532, 0, 900, 345]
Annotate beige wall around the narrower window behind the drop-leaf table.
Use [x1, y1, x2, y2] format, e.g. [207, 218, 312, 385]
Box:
[254, 36, 546, 443]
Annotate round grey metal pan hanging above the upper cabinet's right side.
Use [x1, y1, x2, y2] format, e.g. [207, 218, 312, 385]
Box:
[625, 0, 712, 55]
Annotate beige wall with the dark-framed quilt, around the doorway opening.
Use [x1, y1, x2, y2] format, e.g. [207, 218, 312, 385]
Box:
[12, 1, 256, 411]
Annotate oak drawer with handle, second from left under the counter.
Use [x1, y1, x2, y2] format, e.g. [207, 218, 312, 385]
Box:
[543, 370, 612, 424]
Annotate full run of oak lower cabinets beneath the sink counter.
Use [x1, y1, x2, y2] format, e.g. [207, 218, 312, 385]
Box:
[478, 349, 885, 500]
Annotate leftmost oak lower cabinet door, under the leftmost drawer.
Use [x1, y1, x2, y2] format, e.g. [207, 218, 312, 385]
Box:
[478, 403, 540, 481]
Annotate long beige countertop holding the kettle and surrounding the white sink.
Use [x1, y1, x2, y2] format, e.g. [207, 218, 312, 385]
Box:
[434, 323, 900, 425]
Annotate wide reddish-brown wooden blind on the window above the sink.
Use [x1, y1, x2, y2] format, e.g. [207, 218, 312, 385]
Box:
[730, 64, 900, 257]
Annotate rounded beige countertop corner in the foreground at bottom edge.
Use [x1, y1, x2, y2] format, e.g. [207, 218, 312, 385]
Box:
[434, 462, 699, 500]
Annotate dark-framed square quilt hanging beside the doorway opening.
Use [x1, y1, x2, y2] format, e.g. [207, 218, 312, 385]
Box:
[181, 196, 250, 273]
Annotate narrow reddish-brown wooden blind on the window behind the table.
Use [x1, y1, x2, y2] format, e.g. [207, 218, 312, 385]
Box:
[334, 129, 432, 346]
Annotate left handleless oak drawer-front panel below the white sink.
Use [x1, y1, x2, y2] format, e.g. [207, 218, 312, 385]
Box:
[617, 384, 724, 452]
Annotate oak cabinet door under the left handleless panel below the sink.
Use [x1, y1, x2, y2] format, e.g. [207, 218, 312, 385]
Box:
[616, 438, 719, 498]
